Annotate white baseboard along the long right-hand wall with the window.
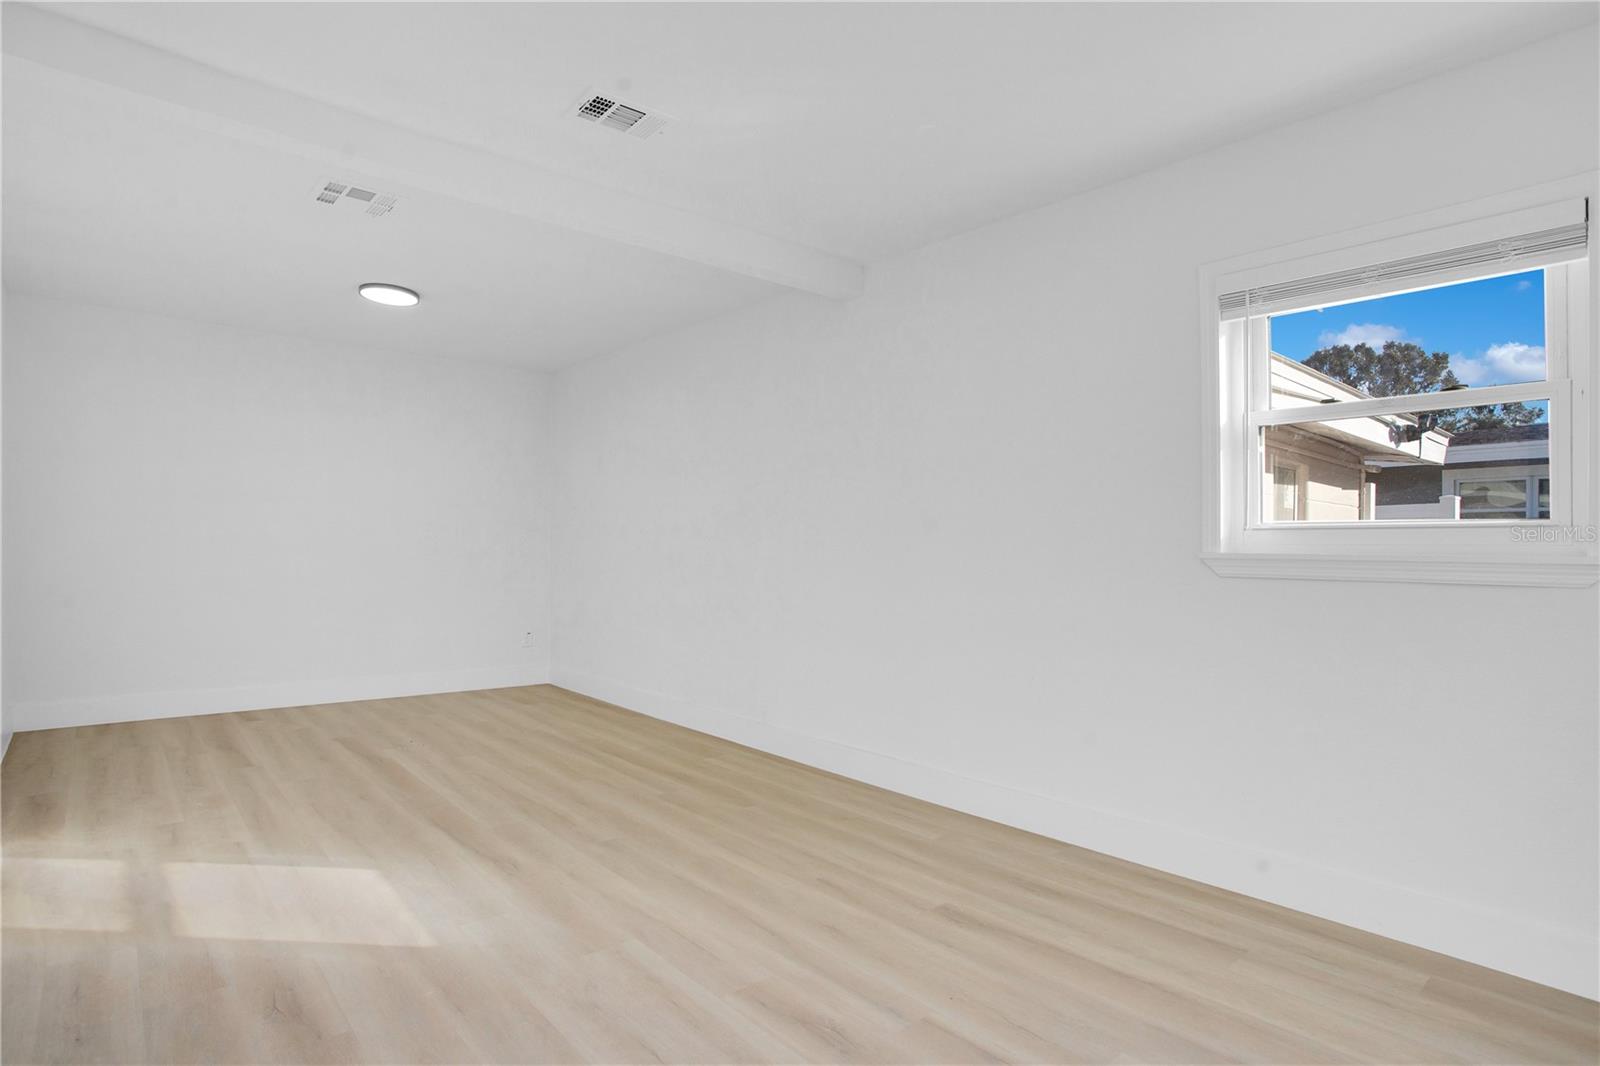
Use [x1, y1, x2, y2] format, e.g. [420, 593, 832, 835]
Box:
[550, 667, 1600, 999]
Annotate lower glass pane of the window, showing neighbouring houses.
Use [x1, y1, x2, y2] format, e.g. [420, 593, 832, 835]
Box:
[1261, 400, 1550, 522]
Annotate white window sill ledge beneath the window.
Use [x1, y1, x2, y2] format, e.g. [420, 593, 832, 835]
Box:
[1200, 552, 1600, 589]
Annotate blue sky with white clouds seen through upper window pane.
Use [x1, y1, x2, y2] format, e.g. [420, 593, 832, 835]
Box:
[1272, 271, 1544, 386]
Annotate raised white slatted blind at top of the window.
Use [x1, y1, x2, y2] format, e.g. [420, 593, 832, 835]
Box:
[1218, 200, 1589, 320]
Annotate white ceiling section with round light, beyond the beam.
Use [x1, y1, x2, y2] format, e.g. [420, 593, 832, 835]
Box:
[3, 62, 779, 365]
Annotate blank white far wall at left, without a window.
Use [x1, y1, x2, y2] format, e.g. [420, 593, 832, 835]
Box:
[3, 291, 550, 730]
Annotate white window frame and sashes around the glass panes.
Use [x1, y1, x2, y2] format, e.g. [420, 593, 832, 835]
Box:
[1200, 173, 1600, 587]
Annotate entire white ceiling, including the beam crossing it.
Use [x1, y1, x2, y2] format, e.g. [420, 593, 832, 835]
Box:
[3, 3, 1597, 365]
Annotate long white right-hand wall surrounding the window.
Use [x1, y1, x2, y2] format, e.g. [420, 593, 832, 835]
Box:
[554, 27, 1600, 996]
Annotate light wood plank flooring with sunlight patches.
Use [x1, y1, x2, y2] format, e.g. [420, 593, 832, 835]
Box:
[0, 687, 1600, 1063]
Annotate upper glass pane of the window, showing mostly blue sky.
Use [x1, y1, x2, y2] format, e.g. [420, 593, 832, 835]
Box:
[1269, 269, 1546, 408]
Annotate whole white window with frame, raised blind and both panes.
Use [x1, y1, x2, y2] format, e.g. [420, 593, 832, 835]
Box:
[1202, 176, 1600, 584]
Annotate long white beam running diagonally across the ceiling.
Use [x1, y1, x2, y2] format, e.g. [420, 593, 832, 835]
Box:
[3, 3, 864, 298]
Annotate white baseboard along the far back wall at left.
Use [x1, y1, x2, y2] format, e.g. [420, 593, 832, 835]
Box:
[5, 664, 549, 733]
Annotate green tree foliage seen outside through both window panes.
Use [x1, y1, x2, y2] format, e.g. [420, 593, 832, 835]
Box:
[1306, 341, 1544, 432]
